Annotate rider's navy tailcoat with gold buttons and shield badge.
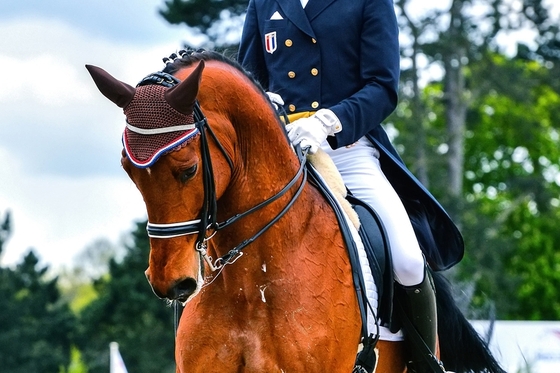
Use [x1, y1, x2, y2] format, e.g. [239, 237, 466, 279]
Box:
[238, 0, 463, 269]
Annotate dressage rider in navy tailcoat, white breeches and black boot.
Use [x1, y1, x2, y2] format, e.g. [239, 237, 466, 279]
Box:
[238, 0, 463, 372]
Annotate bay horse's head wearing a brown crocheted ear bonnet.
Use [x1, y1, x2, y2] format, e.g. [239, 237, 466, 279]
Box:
[86, 61, 231, 301]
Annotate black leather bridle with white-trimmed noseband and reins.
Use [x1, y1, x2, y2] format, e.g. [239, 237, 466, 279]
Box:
[137, 72, 307, 272]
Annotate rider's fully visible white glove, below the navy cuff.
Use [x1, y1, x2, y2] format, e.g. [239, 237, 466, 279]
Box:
[286, 109, 342, 154]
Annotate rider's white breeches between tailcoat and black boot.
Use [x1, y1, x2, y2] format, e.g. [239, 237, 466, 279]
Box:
[321, 137, 424, 286]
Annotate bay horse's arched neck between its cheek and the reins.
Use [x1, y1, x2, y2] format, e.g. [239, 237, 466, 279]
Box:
[199, 77, 299, 218]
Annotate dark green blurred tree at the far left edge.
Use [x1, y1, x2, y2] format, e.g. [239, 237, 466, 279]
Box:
[0, 251, 76, 373]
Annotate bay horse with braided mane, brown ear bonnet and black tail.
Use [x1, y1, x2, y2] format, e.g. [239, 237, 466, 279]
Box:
[86, 51, 503, 373]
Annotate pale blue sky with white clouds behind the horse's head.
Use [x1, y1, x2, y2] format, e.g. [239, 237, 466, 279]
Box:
[0, 0, 560, 268]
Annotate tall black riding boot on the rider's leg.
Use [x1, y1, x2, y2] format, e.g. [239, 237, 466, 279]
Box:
[395, 270, 444, 373]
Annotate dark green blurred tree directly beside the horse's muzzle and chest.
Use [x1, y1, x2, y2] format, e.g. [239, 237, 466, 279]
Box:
[78, 222, 175, 373]
